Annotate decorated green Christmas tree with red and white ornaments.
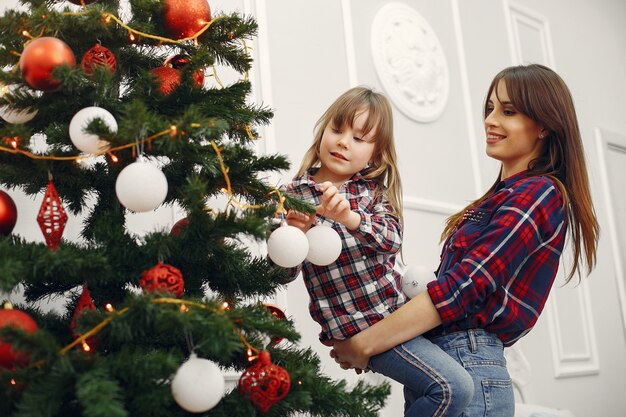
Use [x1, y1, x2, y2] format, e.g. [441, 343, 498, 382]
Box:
[0, 0, 389, 417]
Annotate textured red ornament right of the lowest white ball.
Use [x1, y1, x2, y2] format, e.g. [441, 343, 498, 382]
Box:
[239, 350, 291, 413]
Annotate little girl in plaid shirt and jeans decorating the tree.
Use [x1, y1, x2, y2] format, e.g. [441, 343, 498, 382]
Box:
[280, 87, 474, 417]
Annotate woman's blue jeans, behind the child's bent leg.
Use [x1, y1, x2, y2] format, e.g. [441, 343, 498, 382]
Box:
[431, 329, 515, 417]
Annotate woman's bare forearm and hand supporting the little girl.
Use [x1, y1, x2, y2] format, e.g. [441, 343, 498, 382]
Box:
[331, 291, 441, 369]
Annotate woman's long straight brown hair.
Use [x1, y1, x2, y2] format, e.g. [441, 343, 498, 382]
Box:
[441, 64, 600, 282]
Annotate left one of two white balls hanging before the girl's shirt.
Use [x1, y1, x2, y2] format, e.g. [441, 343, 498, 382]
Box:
[267, 226, 309, 268]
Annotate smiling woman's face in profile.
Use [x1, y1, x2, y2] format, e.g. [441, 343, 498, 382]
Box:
[485, 80, 545, 179]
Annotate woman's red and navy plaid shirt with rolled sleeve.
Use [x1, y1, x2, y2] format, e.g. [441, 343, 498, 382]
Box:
[427, 172, 567, 346]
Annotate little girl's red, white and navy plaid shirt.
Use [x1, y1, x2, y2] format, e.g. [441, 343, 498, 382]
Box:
[287, 171, 405, 341]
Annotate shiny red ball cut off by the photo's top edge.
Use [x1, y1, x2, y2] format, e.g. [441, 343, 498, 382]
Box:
[163, 0, 211, 39]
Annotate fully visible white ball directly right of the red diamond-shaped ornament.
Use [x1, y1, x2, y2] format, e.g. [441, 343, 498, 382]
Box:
[115, 158, 167, 213]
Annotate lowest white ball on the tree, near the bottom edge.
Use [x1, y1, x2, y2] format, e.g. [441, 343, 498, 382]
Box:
[172, 353, 226, 413]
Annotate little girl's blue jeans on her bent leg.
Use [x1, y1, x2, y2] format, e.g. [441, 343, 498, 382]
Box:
[368, 336, 474, 417]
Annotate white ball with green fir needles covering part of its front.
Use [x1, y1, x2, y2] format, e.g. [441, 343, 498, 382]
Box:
[70, 106, 117, 153]
